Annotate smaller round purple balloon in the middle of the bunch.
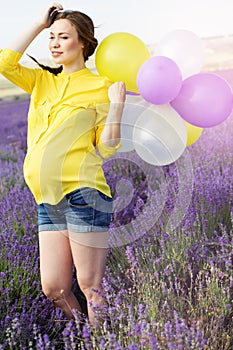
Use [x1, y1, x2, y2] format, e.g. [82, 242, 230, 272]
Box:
[137, 56, 182, 104]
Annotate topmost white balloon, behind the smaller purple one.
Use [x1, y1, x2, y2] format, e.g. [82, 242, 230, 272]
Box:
[156, 29, 204, 79]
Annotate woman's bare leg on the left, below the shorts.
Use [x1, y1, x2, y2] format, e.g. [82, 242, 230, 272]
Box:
[39, 231, 81, 318]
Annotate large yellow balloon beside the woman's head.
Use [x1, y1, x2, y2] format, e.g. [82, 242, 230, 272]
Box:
[95, 32, 151, 92]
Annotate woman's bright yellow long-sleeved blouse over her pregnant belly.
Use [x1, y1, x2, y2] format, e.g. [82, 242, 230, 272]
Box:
[0, 49, 120, 204]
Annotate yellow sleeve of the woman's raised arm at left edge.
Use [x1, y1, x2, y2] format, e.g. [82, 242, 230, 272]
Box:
[0, 48, 39, 94]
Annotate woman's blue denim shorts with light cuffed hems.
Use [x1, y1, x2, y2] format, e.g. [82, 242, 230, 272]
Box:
[38, 187, 113, 232]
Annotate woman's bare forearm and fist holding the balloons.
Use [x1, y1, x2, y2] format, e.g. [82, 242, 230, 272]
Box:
[100, 82, 126, 147]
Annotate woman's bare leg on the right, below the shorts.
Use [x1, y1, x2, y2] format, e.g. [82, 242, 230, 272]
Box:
[70, 232, 107, 325]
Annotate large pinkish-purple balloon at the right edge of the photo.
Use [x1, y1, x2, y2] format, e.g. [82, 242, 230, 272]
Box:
[170, 73, 233, 128]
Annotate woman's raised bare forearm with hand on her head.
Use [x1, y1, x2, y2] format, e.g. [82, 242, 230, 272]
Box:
[8, 3, 63, 53]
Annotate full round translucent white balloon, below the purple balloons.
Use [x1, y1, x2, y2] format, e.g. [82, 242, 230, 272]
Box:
[133, 104, 187, 166]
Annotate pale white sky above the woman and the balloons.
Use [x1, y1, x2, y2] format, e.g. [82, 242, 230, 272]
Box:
[0, 0, 233, 58]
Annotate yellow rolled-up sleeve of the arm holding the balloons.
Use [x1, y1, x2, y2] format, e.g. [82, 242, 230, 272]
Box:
[96, 102, 121, 158]
